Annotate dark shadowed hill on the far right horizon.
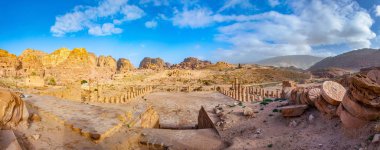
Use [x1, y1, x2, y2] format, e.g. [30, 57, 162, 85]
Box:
[309, 48, 380, 71]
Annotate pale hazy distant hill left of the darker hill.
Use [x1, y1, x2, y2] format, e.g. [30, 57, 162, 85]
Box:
[256, 55, 323, 69]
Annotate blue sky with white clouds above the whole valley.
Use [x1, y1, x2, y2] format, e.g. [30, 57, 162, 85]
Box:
[0, 0, 380, 65]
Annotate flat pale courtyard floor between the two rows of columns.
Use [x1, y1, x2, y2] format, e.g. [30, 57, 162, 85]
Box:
[144, 92, 233, 128]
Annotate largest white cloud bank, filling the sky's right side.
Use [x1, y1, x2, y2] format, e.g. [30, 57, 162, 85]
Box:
[215, 0, 376, 62]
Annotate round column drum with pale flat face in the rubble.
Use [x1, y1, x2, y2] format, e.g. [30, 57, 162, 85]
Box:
[321, 81, 346, 106]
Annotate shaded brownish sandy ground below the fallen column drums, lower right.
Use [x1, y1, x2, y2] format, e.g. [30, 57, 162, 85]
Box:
[209, 101, 380, 150]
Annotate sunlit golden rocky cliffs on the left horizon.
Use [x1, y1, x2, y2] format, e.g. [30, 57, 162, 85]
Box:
[0, 48, 121, 84]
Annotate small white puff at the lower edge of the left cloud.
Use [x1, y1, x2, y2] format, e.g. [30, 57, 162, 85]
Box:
[88, 23, 123, 36]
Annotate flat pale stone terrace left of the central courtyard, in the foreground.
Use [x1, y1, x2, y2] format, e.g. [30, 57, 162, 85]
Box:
[25, 95, 158, 142]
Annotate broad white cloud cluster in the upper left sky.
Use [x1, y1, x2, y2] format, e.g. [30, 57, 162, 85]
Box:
[50, 0, 144, 37]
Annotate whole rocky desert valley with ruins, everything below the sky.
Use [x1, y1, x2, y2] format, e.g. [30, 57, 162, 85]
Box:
[0, 48, 380, 149]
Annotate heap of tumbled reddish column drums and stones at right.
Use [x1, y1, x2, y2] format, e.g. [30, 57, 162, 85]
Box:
[280, 70, 380, 128]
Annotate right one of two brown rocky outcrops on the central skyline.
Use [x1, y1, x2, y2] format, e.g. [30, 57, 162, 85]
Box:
[174, 57, 212, 69]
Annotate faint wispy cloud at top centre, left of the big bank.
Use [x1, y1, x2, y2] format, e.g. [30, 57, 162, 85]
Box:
[173, 8, 214, 28]
